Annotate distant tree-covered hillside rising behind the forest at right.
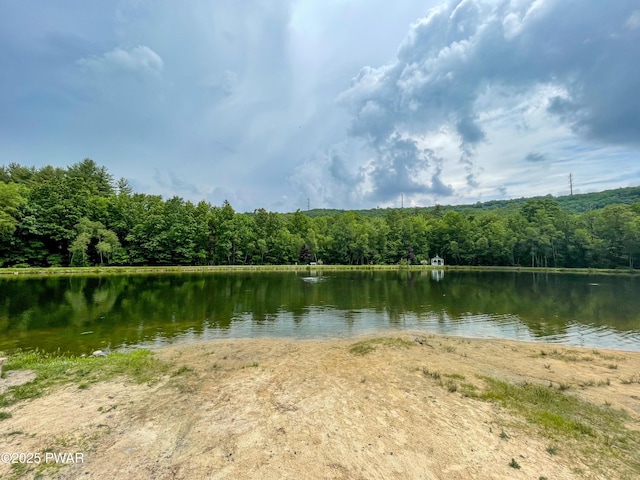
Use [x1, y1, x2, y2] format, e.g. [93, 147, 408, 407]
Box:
[304, 187, 640, 217]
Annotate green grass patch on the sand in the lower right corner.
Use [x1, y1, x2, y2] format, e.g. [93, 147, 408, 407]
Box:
[479, 377, 640, 476]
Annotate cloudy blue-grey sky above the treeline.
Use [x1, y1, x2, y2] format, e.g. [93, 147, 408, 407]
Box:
[0, 0, 640, 212]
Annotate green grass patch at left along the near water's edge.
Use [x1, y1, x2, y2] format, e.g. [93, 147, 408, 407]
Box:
[0, 350, 168, 407]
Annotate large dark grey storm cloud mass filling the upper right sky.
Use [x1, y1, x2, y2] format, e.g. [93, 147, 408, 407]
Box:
[339, 0, 640, 202]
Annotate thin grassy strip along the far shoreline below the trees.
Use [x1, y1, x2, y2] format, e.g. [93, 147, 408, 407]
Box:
[0, 265, 640, 277]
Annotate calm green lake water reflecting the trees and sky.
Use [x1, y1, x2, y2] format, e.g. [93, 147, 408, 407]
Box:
[0, 271, 640, 353]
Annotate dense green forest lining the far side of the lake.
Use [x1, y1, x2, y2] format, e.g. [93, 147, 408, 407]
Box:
[0, 159, 640, 269]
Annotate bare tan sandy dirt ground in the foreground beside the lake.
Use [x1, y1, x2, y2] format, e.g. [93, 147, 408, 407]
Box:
[0, 333, 640, 480]
